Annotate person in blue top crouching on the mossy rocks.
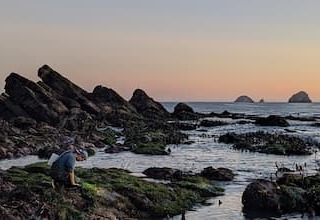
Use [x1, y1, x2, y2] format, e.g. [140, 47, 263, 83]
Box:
[51, 149, 88, 188]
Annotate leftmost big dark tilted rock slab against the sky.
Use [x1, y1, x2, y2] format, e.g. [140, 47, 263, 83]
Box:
[5, 73, 68, 124]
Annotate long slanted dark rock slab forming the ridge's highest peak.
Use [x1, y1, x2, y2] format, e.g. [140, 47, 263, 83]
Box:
[38, 65, 100, 115]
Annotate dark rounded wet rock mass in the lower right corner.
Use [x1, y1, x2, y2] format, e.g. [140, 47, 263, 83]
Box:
[242, 174, 320, 218]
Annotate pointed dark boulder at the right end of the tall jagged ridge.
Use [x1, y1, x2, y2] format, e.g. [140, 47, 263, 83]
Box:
[129, 89, 170, 118]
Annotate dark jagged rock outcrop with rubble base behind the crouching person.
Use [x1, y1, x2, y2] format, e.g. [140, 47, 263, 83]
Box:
[0, 65, 185, 159]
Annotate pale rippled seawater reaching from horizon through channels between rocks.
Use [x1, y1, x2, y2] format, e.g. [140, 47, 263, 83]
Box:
[0, 102, 320, 220]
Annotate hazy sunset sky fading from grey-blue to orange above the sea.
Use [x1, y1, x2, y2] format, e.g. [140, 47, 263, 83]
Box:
[0, 0, 320, 101]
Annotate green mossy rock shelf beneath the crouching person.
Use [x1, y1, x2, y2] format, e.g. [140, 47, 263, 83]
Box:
[0, 163, 223, 219]
